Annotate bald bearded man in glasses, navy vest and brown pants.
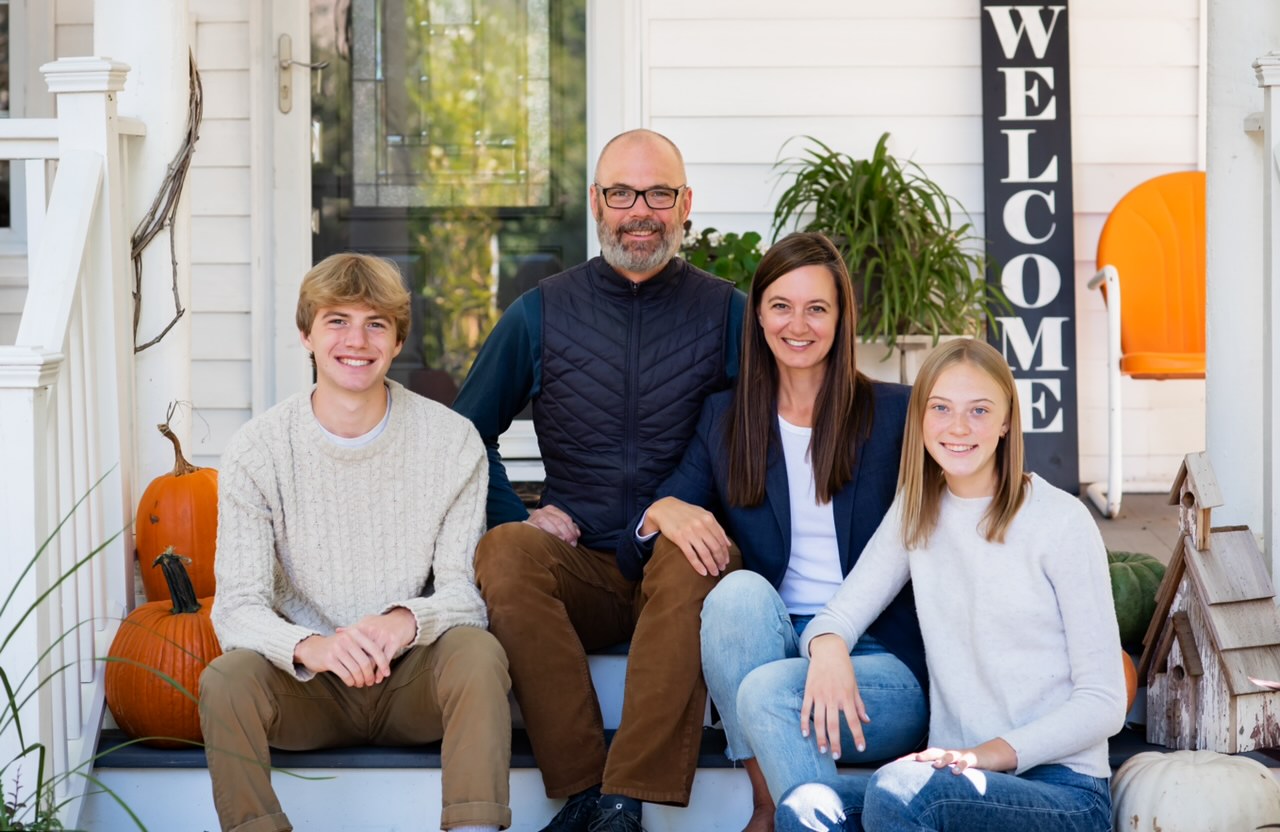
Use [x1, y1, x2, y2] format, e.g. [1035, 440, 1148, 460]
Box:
[454, 131, 746, 832]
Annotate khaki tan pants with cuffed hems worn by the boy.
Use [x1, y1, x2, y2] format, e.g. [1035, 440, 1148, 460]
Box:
[200, 627, 511, 832]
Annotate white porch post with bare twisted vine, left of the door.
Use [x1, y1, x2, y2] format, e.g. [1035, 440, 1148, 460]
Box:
[93, 0, 192, 491]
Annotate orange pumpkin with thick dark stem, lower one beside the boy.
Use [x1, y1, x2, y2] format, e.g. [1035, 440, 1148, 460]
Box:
[106, 547, 223, 748]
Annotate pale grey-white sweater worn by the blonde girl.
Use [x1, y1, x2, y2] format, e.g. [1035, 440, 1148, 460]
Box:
[801, 476, 1125, 777]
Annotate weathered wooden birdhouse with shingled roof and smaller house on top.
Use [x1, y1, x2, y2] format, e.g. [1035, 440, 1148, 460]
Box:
[1138, 453, 1280, 754]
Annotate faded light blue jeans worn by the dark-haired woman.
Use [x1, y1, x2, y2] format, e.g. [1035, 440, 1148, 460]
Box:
[701, 570, 928, 801]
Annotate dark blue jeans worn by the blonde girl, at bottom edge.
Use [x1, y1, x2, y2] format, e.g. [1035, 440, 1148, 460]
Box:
[774, 762, 1111, 832]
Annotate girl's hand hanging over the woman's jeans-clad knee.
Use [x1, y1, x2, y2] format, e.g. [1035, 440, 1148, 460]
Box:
[800, 632, 870, 760]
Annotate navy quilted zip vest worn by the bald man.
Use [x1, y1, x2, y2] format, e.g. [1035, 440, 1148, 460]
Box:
[534, 257, 733, 552]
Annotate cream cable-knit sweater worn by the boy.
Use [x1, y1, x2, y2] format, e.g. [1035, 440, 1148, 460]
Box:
[212, 381, 489, 681]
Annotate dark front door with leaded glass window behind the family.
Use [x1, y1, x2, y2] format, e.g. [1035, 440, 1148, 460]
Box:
[311, 0, 588, 402]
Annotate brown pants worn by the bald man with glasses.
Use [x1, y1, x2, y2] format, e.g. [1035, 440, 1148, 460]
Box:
[476, 522, 741, 806]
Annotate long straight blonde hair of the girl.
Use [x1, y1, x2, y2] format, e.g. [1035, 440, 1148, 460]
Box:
[897, 338, 1028, 549]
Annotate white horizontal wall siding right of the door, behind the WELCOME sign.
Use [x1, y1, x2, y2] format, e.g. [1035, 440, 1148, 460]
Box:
[645, 0, 1204, 481]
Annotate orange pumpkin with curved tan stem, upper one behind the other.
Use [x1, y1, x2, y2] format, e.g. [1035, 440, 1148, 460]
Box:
[134, 421, 218, 600]
